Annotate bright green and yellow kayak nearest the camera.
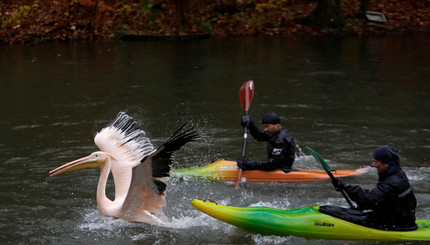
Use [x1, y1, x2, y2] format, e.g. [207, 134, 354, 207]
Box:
[192, 200, 430, 241]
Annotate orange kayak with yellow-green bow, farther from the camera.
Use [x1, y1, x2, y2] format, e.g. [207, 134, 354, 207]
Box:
[171, 159, 368, 183]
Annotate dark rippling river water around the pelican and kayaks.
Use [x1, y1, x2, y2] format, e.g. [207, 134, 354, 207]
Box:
[0, 36, 430, 244]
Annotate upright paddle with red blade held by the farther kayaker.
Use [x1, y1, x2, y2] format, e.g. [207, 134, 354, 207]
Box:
[234, 80, 254, 189]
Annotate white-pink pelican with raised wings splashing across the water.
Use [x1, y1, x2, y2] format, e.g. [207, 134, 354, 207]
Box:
[49, 112, 198, 225]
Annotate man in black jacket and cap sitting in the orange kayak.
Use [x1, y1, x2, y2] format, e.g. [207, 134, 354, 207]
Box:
[238, 112, 295, 171]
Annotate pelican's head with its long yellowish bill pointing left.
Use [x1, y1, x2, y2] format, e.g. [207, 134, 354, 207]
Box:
[49, 151, 114, 176]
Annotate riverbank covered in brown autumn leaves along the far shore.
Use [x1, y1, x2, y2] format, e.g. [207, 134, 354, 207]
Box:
[0, 0, 430, 43]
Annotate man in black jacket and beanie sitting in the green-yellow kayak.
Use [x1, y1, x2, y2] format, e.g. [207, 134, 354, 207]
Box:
[320, 145, 418, 231]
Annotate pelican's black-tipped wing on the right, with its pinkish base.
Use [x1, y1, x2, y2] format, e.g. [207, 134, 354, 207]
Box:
[123, 123, 198, 213]
